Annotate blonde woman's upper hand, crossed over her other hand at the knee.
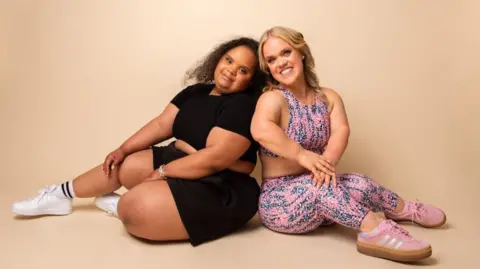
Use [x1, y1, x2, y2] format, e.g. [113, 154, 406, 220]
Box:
[297, 150, 337, 188]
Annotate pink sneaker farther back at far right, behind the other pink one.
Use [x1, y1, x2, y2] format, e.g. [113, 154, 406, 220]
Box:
[385, 201, 447, 228]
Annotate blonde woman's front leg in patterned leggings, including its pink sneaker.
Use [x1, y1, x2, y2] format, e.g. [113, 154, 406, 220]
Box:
[259, 174, 431, 261]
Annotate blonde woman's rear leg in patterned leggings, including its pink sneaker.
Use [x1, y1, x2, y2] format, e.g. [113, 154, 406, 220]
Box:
[338, 173, 446, 227]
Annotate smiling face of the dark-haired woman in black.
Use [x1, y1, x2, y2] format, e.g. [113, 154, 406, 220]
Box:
[214, 46, 257, 94]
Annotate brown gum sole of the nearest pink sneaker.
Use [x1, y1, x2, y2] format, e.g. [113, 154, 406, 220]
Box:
[357, 242, 432, 262]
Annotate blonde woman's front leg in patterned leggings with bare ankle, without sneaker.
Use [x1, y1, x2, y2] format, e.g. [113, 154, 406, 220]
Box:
[259, 174, 390, 233]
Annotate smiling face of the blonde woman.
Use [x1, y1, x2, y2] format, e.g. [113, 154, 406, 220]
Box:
[262, 36, 303, 87]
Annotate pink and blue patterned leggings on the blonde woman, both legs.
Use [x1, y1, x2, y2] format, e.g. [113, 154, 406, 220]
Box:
[258, 173, 399, 233]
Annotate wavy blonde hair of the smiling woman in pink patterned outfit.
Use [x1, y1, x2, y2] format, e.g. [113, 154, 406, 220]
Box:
[258, 26, 327, 100]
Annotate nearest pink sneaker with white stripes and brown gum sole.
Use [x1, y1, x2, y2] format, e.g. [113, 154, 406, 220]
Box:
[357, 220, 432, 262]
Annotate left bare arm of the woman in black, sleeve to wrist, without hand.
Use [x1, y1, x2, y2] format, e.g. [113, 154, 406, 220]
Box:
[119, 104, 179, 155]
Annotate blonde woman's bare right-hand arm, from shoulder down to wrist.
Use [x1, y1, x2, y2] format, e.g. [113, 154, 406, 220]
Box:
[323, 88, 350, 166]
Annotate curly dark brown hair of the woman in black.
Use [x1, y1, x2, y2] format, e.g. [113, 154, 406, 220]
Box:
[184, 37, 266, 95]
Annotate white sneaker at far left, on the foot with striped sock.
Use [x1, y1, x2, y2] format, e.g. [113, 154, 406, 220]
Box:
[12, 185, 72, 216]
